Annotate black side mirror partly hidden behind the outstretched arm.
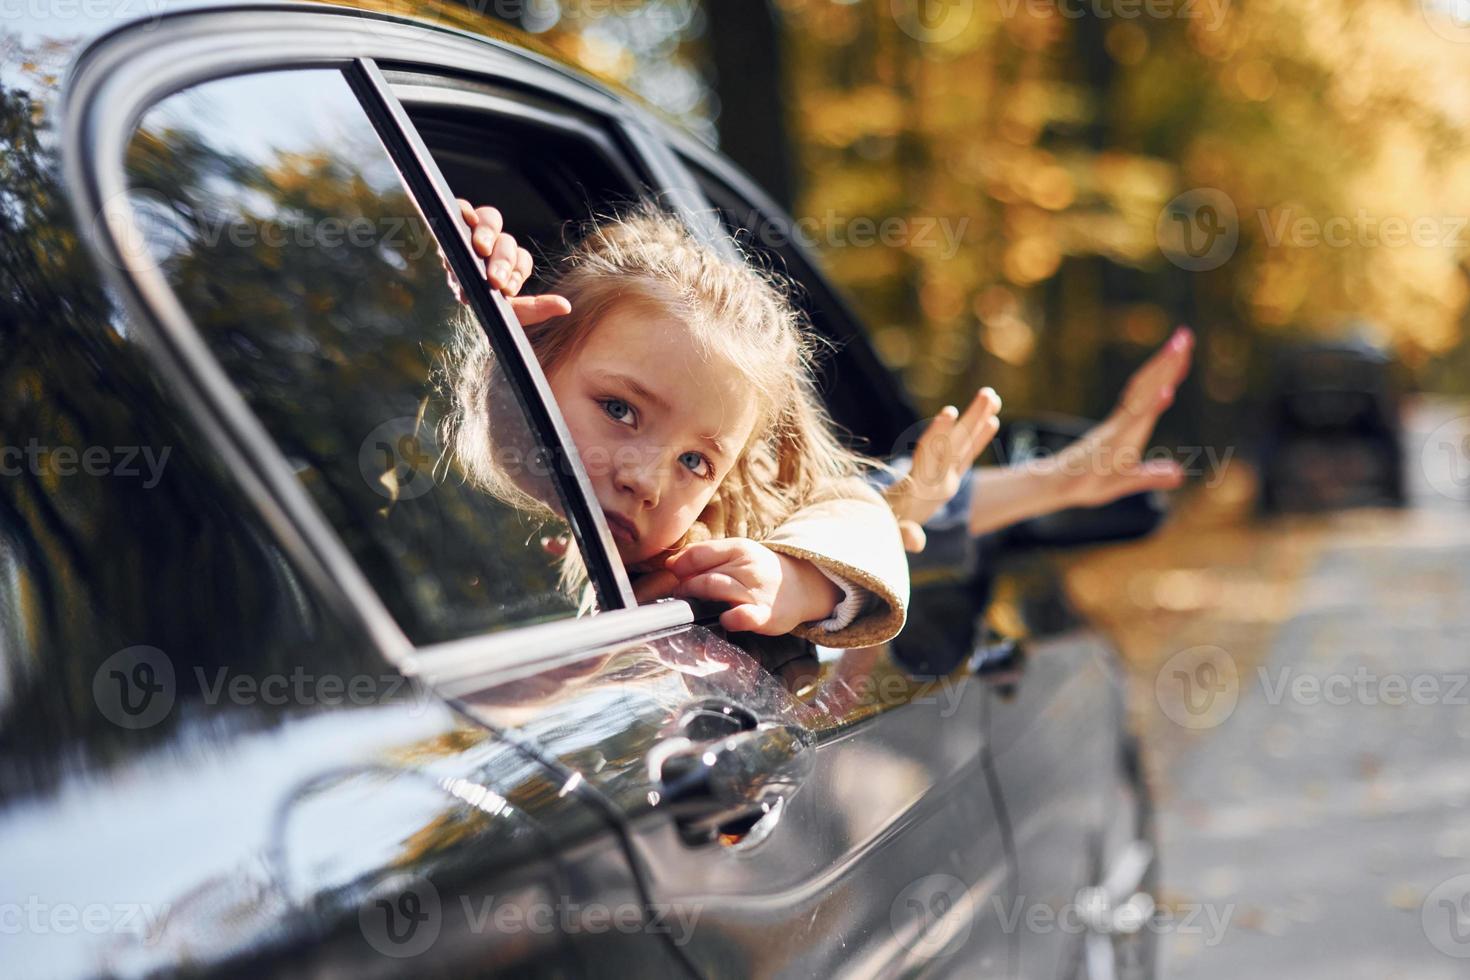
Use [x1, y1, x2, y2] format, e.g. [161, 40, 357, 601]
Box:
[995, 416, 1169, 548]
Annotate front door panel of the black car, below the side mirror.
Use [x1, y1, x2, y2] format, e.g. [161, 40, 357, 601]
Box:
[988, 551, 1128, 979]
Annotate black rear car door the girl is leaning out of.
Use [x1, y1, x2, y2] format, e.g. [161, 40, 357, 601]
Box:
[390, 57, 1008, 977]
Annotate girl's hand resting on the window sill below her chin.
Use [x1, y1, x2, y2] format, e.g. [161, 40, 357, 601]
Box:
[654, 538, 842, 636]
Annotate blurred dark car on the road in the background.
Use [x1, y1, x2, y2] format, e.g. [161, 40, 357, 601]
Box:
[1260, 341, 1407, 513]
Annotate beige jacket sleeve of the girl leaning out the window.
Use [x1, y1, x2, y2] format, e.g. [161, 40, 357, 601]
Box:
[761, 480, 908, 646]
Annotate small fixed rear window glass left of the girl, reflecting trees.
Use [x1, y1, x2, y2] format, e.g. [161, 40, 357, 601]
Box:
[126, 69, 589, 644]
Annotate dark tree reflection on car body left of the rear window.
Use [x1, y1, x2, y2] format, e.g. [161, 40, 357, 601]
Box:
[0, 76, 381, 796]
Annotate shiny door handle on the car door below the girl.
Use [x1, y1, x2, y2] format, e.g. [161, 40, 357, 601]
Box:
[648, 723, 813, 843]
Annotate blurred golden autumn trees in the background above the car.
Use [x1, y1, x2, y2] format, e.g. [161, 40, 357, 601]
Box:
[499, 0, 1470, 449]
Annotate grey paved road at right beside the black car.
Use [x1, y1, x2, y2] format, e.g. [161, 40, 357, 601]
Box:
[1160, 407, 1470, 980]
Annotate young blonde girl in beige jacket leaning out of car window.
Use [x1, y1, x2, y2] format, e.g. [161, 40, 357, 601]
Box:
[451, 201, 908, 646]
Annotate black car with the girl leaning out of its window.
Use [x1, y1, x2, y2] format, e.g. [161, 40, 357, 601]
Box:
[0, 3, 1157, 979]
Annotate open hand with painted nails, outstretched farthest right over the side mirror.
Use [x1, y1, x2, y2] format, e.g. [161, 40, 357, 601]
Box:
[1055, 326, 1194, 507]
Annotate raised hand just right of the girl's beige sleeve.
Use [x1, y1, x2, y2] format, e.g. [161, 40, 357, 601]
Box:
[885, 388, 1001, 531]
